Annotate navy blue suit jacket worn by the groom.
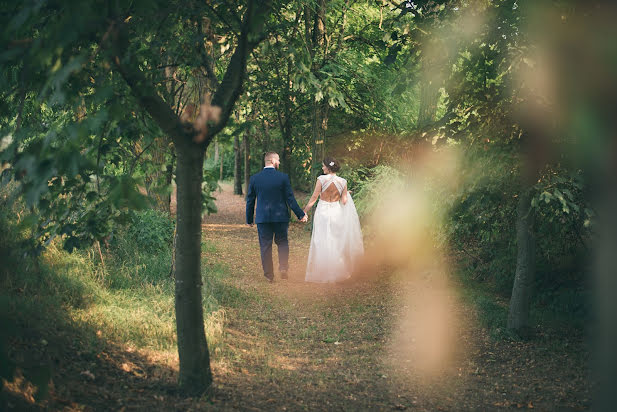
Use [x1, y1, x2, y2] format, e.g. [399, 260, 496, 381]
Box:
[246, 167, 304, 224]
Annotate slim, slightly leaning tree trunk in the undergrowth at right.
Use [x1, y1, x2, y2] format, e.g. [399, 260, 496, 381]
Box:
[508, 185, 535, 332]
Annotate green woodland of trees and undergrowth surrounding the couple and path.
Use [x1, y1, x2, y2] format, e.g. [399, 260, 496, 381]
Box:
[0, 0, 617, 410]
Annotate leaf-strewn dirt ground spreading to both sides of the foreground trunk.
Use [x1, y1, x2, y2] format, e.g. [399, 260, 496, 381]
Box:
[0, 185, 590, 411]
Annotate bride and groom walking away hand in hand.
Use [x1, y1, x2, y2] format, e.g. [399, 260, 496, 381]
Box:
[246, 152, 364, 283]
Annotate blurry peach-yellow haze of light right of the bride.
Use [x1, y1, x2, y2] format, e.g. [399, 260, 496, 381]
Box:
[352, 146, 461, 381]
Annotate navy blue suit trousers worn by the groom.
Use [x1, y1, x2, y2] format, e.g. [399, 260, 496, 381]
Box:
[257, 222, 289, 279]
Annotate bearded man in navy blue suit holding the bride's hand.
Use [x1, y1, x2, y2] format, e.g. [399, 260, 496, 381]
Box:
[246, 152, 308, 282]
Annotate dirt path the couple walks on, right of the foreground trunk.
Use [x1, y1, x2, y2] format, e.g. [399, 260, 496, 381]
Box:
[203, 185, 587, 411]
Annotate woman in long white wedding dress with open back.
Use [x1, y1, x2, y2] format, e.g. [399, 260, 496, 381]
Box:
[304, 157, 364, 283]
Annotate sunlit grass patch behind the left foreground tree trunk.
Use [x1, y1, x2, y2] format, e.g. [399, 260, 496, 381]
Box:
[0, 233, 231, 351]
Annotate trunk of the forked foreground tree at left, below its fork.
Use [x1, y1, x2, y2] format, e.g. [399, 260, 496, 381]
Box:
[175, 142, 212, 394]
